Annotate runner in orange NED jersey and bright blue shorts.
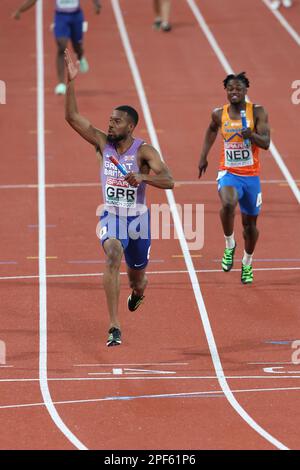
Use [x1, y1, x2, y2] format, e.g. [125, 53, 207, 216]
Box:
[199, 72, 270, 284]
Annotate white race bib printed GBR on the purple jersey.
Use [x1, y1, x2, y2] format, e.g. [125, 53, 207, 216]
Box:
[105, 178, 137, 209]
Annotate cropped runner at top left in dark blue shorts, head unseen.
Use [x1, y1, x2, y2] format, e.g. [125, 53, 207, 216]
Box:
[14, 0, 101, 95]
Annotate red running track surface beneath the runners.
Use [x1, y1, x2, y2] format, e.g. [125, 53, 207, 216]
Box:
[0, 0, 300, 449]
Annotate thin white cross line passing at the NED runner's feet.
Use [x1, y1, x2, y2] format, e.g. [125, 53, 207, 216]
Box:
[0, 266, 300, 281]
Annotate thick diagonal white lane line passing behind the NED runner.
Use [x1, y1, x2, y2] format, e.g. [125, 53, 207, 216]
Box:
[186, 0, 300, 204]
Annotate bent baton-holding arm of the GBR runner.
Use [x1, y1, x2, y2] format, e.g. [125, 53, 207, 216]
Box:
[125, 145, 174, 189]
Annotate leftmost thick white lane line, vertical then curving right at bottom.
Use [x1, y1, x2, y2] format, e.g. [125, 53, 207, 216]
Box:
[36, 0, 86, 450]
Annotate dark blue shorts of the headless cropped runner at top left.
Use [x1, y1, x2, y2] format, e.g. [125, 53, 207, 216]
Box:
[54, 10, 84, 44]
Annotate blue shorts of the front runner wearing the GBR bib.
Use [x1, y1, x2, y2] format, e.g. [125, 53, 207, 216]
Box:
[99, 210, 151, 269]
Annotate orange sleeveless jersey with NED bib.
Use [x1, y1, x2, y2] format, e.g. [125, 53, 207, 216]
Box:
[219, 103, 260, 176]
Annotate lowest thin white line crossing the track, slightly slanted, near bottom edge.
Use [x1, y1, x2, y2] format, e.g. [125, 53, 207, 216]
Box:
[0, 387, 300, 409]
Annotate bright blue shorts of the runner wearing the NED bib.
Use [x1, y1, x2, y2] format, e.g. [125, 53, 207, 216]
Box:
[217, 172, 262, 215]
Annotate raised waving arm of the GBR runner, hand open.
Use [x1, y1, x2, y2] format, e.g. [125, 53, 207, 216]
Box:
[65, 49, 107, 153]
